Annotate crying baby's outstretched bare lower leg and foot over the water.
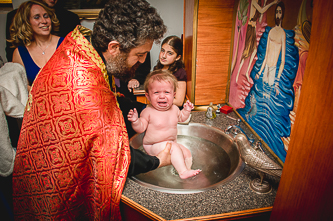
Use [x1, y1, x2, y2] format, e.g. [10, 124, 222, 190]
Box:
[171, 142, 201, 179]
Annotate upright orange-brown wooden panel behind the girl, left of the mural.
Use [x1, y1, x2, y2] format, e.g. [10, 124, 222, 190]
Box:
[195, 0, 234, 105]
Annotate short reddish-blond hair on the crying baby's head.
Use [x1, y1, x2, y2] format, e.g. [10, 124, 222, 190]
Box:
[143, 69, 178, 93]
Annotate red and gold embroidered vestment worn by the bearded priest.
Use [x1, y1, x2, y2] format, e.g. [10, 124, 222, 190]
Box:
[13, 28, 130, 220]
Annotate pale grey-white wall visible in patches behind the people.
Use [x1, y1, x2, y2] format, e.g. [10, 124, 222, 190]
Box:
[0, 0, 184, 68]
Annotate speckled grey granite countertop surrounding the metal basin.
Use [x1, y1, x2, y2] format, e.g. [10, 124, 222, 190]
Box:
[123, 111, 279, 220]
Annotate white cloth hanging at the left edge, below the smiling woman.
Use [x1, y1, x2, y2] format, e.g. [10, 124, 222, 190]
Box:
[0, 62, 28, 176]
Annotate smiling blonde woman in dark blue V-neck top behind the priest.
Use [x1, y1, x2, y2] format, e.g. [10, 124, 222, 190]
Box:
[9, 0, 63, 86]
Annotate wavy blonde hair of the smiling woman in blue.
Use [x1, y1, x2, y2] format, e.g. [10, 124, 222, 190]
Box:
[7, 0, 59, 47]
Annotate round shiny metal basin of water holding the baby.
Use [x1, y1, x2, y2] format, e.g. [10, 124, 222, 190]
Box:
[130, 123, 244, 194]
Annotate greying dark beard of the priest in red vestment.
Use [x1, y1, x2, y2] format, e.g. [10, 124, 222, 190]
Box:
[106, 52, 140, 81]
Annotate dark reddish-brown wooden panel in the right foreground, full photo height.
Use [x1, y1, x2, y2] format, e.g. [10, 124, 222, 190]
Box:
[271, 0, 333, 221]
